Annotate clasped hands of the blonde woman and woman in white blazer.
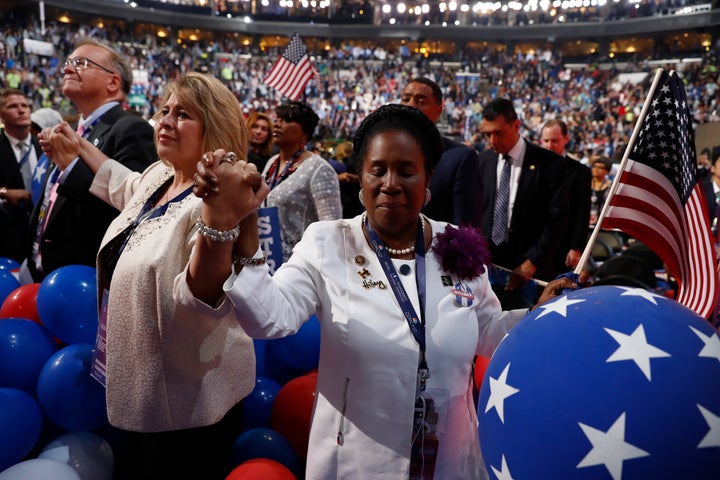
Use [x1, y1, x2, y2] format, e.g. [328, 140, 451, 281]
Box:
[193, 149, 270, 230]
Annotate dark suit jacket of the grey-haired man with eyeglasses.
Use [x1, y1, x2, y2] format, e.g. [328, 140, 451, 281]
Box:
[28, 105, 157, 282]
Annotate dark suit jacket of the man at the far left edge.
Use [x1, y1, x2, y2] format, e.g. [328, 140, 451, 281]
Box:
[0, 130, 42, 262]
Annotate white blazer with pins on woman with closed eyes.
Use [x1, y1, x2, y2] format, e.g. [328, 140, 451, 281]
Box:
[225, 216, 526, 480]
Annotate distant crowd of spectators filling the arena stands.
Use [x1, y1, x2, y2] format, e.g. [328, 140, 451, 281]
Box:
[0, 15, 720, 164]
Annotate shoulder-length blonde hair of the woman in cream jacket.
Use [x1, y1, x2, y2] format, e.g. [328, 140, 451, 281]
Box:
[154, 72, 248, 159]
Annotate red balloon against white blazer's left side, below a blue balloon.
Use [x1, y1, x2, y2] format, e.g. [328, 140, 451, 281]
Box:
[270, 373, 317, 459]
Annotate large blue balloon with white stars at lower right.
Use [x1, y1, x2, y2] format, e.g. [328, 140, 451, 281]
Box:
[478, 286, 720, 480]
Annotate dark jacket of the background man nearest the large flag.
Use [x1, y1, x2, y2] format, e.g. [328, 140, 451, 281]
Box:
[556, 156, 592, 271]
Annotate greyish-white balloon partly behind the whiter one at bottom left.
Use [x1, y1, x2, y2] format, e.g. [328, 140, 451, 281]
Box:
[38, 432, 114, 480]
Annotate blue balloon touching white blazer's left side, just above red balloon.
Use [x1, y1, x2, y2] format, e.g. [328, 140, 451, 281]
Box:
[265, 315, 320, 376]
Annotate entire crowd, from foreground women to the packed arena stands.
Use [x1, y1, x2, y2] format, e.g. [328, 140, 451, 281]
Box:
[0, 6, 720, 479]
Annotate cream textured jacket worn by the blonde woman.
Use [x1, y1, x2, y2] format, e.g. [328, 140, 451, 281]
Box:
[90, 160, 255, 432]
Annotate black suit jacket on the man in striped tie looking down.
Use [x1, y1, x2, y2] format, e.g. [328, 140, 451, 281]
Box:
[480, 140, 568, 280]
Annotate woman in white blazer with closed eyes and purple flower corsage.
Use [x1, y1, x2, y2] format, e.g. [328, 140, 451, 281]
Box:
[190, 105, 572, 480]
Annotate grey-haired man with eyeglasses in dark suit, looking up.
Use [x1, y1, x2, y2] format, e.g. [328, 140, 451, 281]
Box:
[23, 39, 157, 282]
